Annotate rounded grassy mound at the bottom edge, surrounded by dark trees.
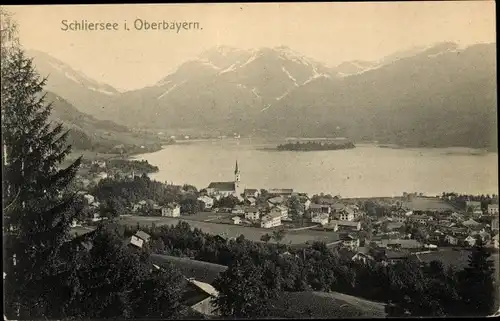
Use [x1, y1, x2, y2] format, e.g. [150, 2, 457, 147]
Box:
[269, 291, 386, 319]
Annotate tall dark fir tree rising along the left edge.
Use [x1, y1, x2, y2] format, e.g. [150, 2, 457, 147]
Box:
[1, 11, 80, 318]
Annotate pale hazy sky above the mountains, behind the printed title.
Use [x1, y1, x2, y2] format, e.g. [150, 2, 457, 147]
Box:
[6, 1, 496, 90]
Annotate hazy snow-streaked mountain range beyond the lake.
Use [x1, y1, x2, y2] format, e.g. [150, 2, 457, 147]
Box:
[28, 42, 497, 150]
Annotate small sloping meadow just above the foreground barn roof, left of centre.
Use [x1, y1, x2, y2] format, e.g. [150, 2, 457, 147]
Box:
[151, 254, 227, 284]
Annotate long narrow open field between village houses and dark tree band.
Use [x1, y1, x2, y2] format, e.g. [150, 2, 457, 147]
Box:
[119, 213, 338, 245]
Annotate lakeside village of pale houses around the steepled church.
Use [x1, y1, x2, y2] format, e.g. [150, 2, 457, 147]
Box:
[73, 161, 499, 257]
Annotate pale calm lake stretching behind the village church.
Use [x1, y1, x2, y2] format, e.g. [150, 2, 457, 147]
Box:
[134, 139, 498, 197]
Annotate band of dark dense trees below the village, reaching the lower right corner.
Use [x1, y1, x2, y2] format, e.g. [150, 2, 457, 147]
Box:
[124, 222, 494, 317]
